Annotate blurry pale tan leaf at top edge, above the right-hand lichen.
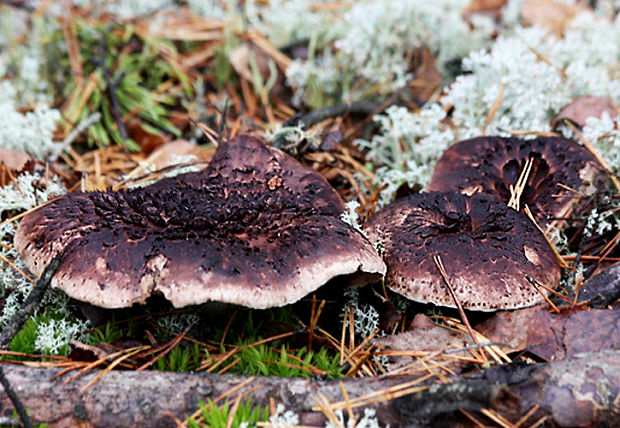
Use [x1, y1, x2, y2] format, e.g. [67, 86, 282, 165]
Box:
[521, 0, 585, 35]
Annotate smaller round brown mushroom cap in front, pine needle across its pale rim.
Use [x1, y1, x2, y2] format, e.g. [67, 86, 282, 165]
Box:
[365, 192, 561, 311]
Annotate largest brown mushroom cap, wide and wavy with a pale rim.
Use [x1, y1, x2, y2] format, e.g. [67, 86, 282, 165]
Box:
[15, 136, 385, 308]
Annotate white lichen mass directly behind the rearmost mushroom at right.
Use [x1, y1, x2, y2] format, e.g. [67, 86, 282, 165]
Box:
[357, 8, 620, 204]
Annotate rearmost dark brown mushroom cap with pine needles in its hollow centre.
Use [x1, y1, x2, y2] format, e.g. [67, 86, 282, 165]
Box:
[428, 137, 605, 227]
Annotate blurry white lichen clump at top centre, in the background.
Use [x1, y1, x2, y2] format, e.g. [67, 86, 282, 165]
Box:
[287, 0, 494, 106]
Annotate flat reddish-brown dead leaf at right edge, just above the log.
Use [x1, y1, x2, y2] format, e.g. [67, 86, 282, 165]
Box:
[527, 309, 620, 361]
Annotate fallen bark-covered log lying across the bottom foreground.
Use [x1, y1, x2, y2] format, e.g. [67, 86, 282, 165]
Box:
[0, 350, 620, 427]
